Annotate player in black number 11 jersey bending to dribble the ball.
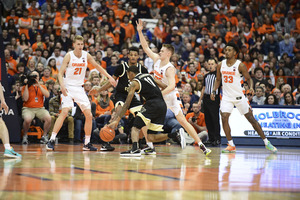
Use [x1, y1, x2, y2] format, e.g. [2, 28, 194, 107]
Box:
[108, 66, 167, 156]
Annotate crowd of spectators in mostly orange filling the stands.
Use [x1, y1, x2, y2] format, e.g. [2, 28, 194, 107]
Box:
[1, 0, 300, 144]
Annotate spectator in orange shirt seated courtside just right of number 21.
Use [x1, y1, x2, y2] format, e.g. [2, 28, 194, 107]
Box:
[96, 90, 114, 129]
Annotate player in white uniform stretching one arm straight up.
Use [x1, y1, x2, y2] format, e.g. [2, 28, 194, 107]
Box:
[137, 19, 211, 155]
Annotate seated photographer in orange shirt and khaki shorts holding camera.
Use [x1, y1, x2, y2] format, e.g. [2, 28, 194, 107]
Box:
[22, 71, 51, 144]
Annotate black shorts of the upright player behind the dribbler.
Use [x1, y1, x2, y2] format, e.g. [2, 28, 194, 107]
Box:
[111, 92, 142, 113]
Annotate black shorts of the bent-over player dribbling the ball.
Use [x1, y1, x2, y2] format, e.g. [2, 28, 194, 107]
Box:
[133, 99, 167, 131]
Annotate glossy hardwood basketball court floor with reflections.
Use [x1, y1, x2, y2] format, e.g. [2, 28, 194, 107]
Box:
[0, 144, 300, 200]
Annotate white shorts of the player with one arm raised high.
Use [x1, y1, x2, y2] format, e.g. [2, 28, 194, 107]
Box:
[164, 90, 182, 116]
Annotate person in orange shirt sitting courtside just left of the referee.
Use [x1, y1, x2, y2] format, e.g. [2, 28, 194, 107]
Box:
[186, 102, 208, 144]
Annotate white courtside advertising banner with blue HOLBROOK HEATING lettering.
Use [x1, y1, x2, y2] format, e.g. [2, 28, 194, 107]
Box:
[221, 107, 300, 139]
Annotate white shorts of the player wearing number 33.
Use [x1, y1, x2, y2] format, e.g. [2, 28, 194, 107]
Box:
[220, 97, 250, 115]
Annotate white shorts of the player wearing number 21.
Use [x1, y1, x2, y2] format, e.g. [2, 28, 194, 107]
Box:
[61, 86, 91, 111]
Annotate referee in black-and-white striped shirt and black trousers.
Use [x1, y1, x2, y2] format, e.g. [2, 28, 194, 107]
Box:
[199, 58, 221, 146]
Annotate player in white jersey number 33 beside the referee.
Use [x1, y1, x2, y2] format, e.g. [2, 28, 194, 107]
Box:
[211, 42, 277, 153]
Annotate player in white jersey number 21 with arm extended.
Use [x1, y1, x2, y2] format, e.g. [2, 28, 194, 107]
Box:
[46, 35, 117, 151]
